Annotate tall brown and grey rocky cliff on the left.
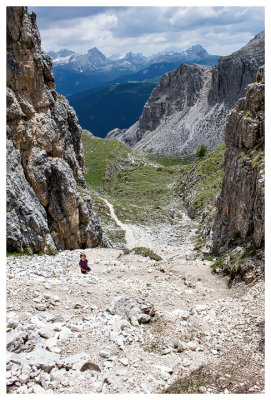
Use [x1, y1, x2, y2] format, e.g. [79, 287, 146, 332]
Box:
[7, 7, 103, 252]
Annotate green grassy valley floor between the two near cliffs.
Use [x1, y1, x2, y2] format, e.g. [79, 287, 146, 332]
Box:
[82, 134, 190, 223]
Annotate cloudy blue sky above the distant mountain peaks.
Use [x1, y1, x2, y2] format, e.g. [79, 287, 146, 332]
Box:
[28, 6, 264, 56]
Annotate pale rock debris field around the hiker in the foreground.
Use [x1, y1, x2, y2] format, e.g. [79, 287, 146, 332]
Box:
[7, 215, 264, 394]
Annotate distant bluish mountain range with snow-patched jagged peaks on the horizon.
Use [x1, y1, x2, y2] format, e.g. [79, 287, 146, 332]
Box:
[48, 45, 219, 96]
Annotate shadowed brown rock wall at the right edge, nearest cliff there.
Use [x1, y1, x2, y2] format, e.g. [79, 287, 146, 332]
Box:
[213, 67, 265, 253]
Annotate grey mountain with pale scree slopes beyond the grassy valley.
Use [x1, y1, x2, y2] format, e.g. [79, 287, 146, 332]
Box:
[107, 32, 264, 156]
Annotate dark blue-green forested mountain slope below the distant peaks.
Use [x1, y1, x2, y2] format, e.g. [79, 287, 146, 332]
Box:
[68, 82, 155, 137]
